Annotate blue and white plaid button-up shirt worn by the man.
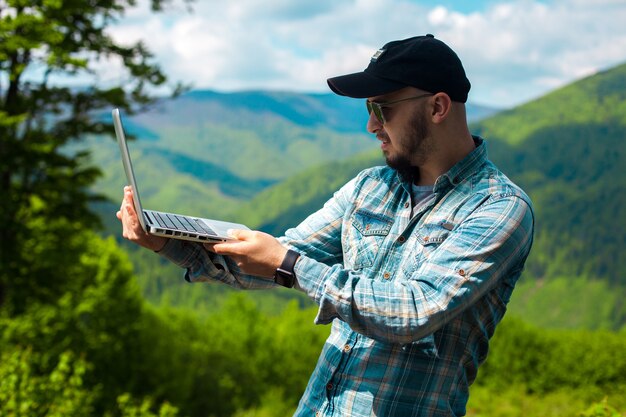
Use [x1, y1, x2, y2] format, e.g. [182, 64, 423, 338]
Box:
[161, 138, 534, 417]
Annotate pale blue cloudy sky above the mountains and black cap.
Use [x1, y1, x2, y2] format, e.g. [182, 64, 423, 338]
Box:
[107, 0, 626, 108]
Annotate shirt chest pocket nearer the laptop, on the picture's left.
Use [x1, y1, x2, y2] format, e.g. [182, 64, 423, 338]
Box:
[344, 209, 393, 269]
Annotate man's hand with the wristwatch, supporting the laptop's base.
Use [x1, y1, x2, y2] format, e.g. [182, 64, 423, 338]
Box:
[204, 230, 287, 278]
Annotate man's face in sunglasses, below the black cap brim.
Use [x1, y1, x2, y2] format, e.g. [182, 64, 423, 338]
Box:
[367, 88, 434, 177]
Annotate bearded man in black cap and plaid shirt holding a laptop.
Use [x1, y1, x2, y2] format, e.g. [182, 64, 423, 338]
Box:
[118, 35, 534, 416]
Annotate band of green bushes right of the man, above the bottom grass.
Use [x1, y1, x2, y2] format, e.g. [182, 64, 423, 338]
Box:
[477, 319, 626, 394]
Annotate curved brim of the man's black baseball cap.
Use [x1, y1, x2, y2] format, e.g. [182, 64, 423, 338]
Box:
[326, 72, 406, 98]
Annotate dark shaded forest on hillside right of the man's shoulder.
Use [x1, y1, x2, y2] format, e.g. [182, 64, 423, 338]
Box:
[490, 120, 626, 292]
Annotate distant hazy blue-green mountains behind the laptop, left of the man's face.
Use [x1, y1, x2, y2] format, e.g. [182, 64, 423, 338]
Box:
[87, 91, 495, 221]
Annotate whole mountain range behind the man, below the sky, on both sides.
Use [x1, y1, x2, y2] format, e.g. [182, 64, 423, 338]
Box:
[88, 65, 626, 329]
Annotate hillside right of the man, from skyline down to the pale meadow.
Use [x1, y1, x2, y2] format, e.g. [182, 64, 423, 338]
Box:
[475, 65, 626, 285]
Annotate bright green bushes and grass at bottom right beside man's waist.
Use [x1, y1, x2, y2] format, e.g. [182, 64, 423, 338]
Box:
[460, 317, 626, 417]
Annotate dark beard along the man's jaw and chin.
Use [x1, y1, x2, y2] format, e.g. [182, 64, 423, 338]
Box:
[384, 111, 434, 182]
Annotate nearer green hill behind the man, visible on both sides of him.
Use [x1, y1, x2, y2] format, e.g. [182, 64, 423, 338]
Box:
[236, 61, 626, 328]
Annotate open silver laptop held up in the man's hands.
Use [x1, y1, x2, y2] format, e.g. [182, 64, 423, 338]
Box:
[112, 109, 250, 242]
